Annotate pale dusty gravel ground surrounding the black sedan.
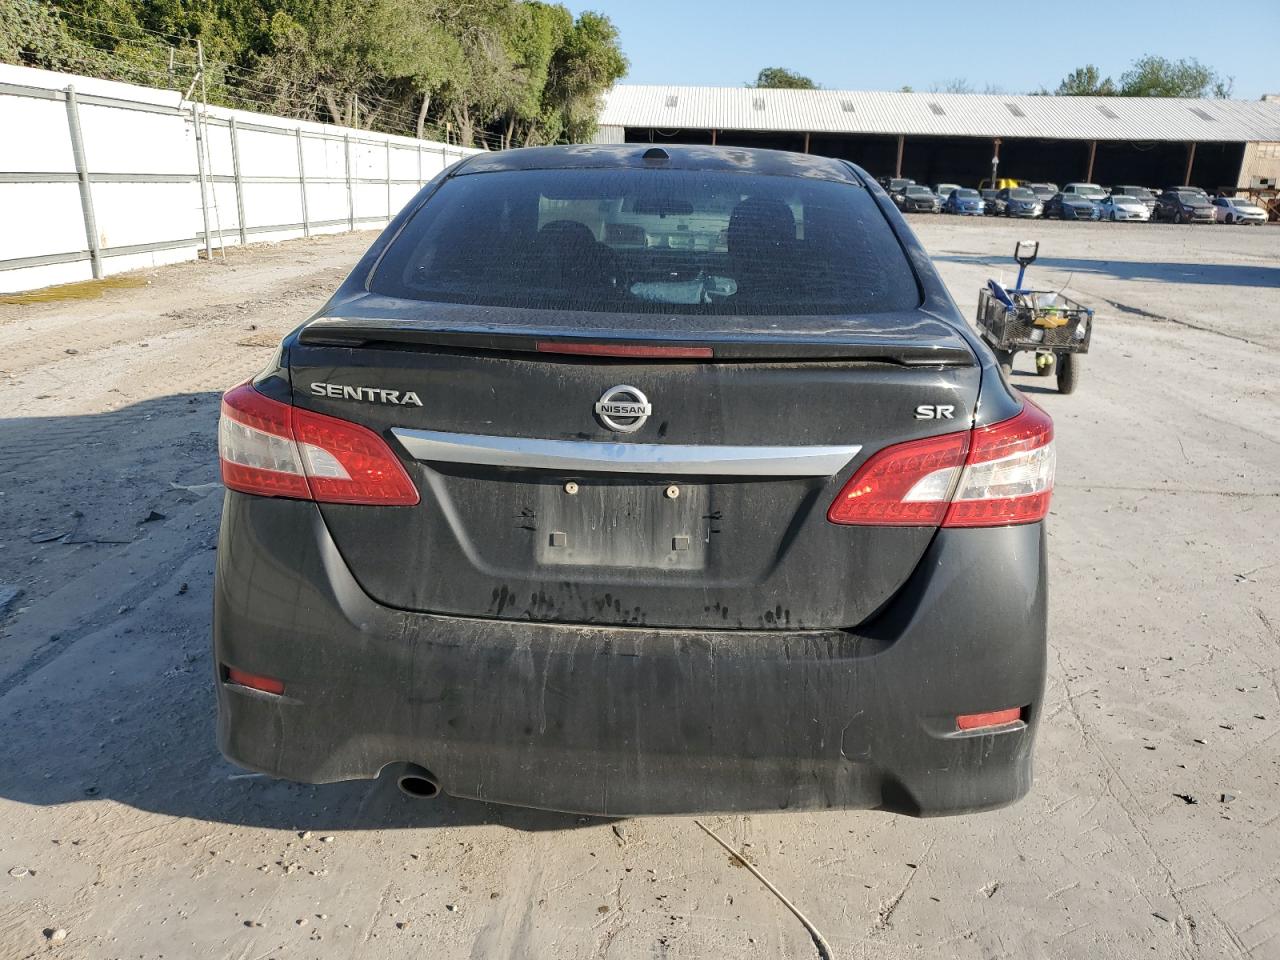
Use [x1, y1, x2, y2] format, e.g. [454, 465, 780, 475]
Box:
[0, 218, 1280, 960]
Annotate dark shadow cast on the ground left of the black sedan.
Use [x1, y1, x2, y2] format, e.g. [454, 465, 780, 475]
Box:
[0, 393, 608, 831]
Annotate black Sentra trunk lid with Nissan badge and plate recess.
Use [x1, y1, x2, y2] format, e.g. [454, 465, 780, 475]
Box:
[289, 296, 979, 630]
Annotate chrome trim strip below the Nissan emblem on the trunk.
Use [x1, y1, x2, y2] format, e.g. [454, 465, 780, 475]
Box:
[392, 428, 861, 476]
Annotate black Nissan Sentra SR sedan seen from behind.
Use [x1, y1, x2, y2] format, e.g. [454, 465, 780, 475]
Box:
[214, 145, 1053, 815]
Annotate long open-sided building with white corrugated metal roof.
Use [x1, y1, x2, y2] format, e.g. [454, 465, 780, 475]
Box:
[596, 84, 1280, 188]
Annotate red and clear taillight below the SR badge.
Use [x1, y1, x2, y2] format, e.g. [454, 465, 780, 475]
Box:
[827, 401, 1053, 527]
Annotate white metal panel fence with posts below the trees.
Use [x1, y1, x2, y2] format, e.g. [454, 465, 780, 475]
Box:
[0, 64, 475, 292]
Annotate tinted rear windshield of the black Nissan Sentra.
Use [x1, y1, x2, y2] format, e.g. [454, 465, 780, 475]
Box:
[369, 169, 920, 316]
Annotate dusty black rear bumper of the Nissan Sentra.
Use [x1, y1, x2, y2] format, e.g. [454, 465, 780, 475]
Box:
[214, 493, 1046, 815]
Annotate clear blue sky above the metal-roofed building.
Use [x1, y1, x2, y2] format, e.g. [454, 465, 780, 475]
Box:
[566, 0, 1280, 100]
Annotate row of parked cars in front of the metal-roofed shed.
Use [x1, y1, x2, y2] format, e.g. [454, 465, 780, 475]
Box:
[879, 177, 1267, 224]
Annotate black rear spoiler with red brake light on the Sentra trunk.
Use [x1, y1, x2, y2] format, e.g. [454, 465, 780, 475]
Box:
[298, 317, 977, 366]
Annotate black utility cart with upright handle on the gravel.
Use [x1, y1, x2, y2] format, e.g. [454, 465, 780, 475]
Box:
[978, 241, 1093, 393]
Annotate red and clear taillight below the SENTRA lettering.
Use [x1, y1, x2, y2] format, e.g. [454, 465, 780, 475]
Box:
[218, 383, 419, 507]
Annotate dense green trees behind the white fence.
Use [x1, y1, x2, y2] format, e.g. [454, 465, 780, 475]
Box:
[0, 0, 627, 146]
